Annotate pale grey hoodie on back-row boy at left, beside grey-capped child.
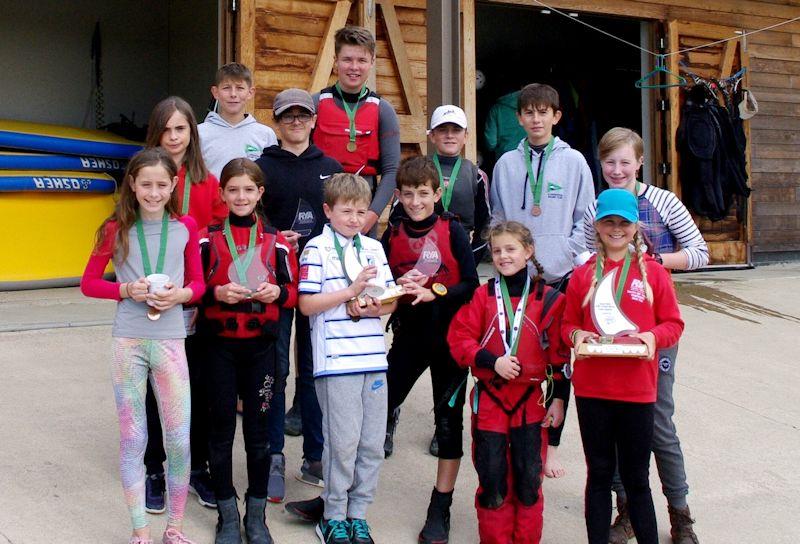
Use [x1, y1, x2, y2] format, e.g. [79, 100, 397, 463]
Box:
[197, 111, 278, 178]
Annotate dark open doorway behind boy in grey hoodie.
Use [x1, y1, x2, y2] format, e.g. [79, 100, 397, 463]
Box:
[475, 2, 652, 190]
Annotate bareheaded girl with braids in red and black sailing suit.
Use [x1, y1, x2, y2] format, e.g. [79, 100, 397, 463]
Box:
[447, 221, 569, 544]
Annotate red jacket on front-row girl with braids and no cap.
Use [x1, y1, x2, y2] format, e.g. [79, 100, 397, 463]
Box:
[447, 280, 569, 408]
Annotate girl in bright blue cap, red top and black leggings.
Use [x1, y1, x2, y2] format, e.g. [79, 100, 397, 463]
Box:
[562, 189, 683, 544]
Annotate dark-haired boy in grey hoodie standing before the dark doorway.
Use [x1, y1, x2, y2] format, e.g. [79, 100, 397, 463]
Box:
[489, 83, 594, 478]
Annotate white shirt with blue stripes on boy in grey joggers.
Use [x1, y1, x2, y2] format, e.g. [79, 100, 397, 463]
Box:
[298, 225, 394, 378]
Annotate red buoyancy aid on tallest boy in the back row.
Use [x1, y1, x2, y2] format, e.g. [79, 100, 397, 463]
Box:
[314, 87, 381, 176]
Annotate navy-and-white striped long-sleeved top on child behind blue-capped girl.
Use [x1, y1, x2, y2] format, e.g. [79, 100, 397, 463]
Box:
[583, 184, 708, 270]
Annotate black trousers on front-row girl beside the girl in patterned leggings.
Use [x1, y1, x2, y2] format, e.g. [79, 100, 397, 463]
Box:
[208, 337, 277, 500]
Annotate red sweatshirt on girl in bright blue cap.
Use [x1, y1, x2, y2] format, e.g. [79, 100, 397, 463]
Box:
[562, 256, 683, 402]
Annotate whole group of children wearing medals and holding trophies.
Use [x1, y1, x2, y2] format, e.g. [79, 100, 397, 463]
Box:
[81, 23, 708, 544]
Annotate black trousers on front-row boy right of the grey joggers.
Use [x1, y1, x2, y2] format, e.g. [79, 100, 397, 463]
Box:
[386, 326, 467, 459]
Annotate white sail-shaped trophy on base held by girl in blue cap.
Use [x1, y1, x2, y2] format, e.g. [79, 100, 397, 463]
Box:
[578, 268, 650, 358]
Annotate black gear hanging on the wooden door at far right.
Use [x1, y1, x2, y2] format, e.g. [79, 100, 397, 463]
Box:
[677, 85, 750, 221]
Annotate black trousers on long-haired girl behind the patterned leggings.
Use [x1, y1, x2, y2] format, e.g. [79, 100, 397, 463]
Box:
[144, 334, 208, 475]
